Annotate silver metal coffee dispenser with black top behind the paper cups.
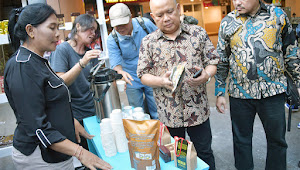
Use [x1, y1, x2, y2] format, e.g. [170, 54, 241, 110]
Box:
[89, 67, 122, 123]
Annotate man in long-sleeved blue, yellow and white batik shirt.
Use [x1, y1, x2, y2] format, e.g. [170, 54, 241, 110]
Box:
[215, 0, 300, 170]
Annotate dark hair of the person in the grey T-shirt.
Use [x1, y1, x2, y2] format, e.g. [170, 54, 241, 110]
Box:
[70, 14, 100, 42]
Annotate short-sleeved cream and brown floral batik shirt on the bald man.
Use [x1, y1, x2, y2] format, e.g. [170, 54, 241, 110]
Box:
[137, 24, 219, 128]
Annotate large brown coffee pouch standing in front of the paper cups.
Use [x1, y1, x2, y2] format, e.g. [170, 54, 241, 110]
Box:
[123, 119, 160, 170]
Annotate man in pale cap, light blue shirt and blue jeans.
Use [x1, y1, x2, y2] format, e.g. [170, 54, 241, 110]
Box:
[107, 3, 158, 119]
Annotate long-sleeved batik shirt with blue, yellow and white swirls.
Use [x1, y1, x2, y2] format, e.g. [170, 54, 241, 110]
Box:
[215, 3, 300, 99]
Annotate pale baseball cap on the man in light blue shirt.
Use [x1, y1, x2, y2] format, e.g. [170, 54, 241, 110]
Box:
[109, 3, 131, 27]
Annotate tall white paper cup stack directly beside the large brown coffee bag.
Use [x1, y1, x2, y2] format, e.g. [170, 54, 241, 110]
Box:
[110, 109, 128, 152]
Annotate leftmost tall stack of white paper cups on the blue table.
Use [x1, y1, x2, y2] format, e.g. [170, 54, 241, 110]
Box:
[100, 118, 117, 157]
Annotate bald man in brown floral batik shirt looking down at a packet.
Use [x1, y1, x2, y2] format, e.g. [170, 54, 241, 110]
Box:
[137, 0, 219, 170]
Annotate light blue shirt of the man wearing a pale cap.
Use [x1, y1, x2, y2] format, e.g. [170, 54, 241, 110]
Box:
[107, 18, 157, 88]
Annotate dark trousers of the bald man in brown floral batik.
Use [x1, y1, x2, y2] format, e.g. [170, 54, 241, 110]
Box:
[168, 119, 215, 170]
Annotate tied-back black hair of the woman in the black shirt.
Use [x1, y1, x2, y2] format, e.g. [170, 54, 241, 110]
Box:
[8, 3, 56, 50]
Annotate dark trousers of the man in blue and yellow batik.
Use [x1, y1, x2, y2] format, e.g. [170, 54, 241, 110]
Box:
[229, 94, 287, 170]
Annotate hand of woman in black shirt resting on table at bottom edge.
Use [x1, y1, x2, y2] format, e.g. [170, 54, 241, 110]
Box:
[78, 149, 112, 170]
